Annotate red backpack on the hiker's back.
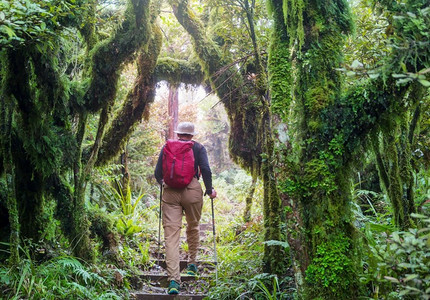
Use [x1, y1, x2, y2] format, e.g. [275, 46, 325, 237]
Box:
[163, 140, 196, 188]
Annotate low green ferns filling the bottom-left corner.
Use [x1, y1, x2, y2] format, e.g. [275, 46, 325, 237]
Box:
[0, 246, 129, 299]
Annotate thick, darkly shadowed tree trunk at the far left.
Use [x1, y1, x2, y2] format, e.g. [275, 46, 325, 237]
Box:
[5, 50, 55, 241]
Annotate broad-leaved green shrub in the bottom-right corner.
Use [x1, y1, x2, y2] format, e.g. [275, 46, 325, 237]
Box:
[361, 212, 430, 300]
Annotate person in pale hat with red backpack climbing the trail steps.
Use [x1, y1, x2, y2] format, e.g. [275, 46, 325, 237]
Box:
[154, 122, 216, 294]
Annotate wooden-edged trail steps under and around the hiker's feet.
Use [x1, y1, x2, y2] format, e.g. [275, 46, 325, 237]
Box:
[133, 223, 215, 300]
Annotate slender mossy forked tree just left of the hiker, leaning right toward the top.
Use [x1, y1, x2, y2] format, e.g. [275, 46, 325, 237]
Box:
[74, 0, 161, 259]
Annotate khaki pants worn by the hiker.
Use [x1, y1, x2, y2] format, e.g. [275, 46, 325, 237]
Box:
[161, 178, 203, 282]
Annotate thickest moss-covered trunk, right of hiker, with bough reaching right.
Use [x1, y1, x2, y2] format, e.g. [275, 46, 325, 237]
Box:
[270, 0, 429, 299]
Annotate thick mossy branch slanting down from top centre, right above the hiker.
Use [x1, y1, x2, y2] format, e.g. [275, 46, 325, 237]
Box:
[170, 0, 262, 172]
